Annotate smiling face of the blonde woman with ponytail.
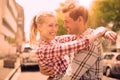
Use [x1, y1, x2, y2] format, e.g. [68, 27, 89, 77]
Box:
[38, 16, 58, 41]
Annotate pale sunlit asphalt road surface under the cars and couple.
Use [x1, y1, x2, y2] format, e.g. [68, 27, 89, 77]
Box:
[11, 69, 120, 80]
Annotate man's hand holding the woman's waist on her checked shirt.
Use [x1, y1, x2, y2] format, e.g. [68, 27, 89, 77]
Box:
[39, 65, 55, 76]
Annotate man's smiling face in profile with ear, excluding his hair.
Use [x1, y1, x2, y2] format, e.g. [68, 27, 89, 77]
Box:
[63, 12, 86, 35]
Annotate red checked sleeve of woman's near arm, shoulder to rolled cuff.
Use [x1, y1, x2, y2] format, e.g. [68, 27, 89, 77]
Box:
[37, 37, 89, 58]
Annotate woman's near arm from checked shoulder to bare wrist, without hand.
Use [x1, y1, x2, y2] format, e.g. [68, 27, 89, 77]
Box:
[37, 27, 106, 58]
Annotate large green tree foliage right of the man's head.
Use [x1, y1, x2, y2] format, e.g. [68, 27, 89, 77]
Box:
[88, 0, 120, 31]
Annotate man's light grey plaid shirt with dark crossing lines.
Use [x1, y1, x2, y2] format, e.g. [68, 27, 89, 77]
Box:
[61, 29, 103, 80]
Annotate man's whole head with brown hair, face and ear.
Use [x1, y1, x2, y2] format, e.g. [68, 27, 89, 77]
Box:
[63, 6, 88, 36]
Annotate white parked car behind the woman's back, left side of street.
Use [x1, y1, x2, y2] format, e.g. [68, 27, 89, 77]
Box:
[20, 47, 38, 71]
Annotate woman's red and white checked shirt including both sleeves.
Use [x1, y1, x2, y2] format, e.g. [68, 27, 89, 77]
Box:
[37, 35, 89, 74]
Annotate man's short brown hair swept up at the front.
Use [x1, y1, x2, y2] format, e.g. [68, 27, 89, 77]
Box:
[62, 3, 88, 22]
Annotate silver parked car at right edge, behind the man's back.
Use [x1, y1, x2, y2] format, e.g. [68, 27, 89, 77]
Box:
[103, 52, 120, 76]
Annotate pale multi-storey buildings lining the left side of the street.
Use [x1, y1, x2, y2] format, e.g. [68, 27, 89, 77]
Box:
[0, 0, 24, 56]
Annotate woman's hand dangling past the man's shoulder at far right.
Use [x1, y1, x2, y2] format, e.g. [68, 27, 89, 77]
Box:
[104, 31, 117, 42]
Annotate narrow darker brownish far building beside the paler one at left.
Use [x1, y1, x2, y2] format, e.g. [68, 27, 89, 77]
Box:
[16, 3, 25, 51]
